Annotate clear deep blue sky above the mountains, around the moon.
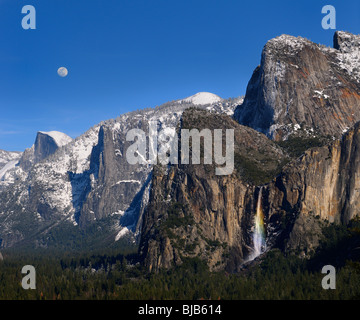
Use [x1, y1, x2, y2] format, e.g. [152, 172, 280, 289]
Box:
[0, 0, 360, 151]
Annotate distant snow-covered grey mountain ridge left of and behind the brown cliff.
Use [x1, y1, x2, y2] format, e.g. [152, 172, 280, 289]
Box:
[0, 98, 242, 247]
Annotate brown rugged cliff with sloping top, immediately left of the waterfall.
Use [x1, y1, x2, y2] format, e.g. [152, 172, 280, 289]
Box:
[140, 110, 287, 271]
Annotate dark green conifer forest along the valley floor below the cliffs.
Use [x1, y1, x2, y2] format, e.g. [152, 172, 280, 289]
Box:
[0, 221, 360, 300]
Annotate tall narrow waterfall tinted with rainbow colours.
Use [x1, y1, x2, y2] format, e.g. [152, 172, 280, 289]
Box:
[249, 187, 266, 260]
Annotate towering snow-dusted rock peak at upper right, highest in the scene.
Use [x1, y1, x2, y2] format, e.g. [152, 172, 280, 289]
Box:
[234, 32, 360, 140]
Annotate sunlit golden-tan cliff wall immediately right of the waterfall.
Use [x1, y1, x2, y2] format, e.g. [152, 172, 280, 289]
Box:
[263, 123, 360, 254]
